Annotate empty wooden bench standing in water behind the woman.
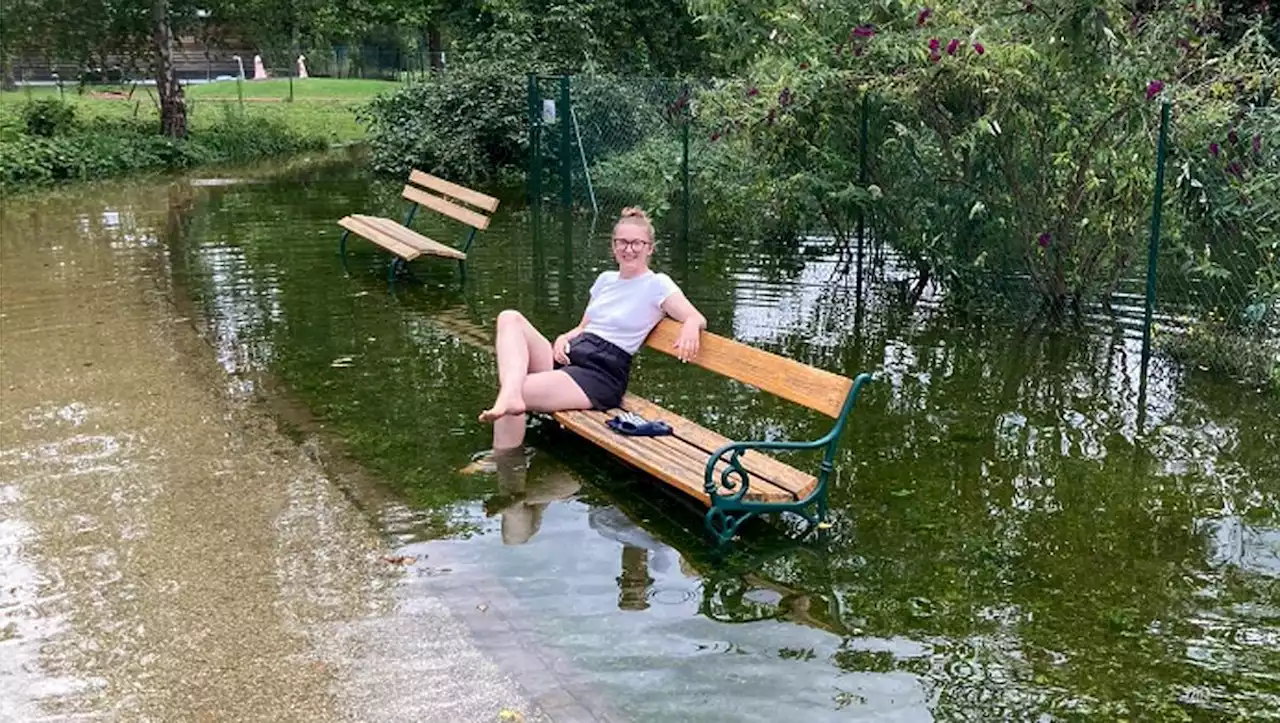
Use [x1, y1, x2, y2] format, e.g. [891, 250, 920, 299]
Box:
[338, 170, 498, 282]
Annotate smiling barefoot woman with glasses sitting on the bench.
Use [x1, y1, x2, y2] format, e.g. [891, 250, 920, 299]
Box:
[480, 209, 707, 452]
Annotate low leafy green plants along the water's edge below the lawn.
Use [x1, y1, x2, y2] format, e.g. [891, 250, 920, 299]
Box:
[0, 119, 324, 191]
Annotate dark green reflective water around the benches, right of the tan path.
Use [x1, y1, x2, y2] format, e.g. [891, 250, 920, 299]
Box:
[154, 160, 1280, 720]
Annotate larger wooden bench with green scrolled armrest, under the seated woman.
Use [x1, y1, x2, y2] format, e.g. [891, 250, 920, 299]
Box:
[552, 319, 870, 543]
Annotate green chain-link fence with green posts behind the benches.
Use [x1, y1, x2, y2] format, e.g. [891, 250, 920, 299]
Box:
[529, 77, 1280, 385]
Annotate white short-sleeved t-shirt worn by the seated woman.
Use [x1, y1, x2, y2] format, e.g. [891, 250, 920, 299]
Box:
[582, 271, 680, 354]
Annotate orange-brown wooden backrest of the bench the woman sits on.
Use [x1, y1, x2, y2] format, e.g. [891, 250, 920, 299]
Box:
[645, 319, 854, 418]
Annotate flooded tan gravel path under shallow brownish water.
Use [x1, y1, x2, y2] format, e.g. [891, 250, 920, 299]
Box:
[0, 171, 560, 720]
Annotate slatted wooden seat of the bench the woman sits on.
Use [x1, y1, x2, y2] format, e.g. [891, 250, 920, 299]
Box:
[553, 394, 818, 505]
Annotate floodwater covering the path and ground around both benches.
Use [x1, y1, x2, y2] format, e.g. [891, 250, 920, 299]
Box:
[0, 154, 1280, 720]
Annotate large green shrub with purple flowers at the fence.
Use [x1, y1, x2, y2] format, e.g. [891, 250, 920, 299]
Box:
[694, 0, 1280, 308]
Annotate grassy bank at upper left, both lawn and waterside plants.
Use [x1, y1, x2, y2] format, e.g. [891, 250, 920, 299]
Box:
[0, 78, 397, 191]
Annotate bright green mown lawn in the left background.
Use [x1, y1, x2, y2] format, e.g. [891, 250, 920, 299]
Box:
[0, 78, 399, 143]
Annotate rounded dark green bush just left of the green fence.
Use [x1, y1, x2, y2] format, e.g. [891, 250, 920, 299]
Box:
[358, 58, 529, 182]
